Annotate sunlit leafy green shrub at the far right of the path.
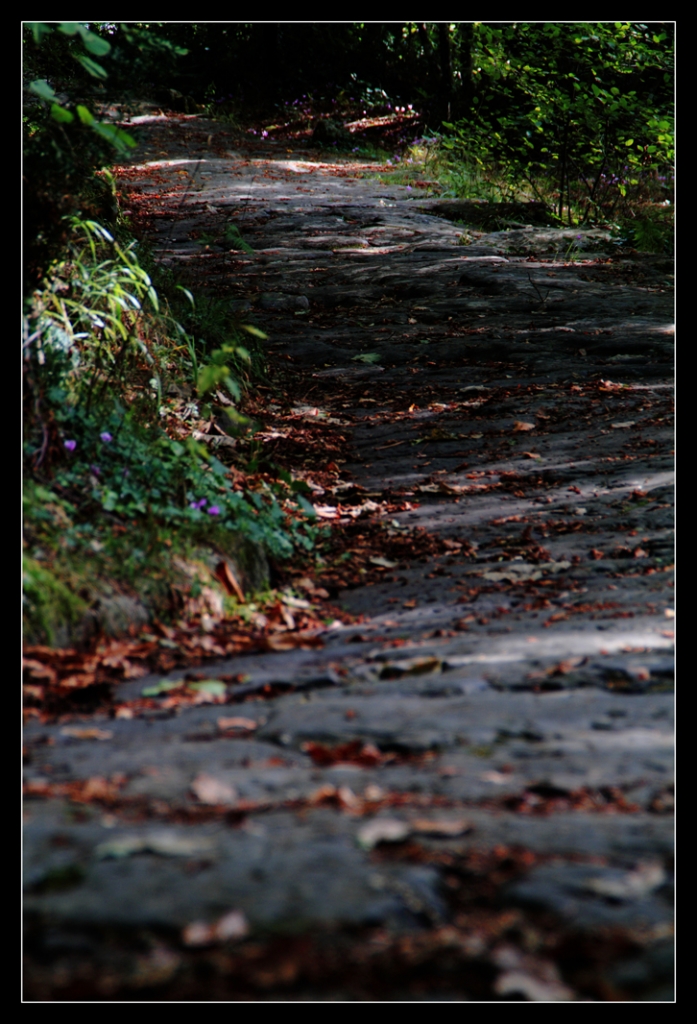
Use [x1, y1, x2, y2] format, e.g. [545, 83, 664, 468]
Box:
[439, 23, 673, 223]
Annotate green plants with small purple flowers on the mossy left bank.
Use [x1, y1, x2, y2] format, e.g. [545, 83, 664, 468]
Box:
[24, 206, 315, 642]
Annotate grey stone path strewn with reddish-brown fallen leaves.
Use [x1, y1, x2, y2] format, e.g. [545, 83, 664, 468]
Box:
[25, 118, 673, 1000]
